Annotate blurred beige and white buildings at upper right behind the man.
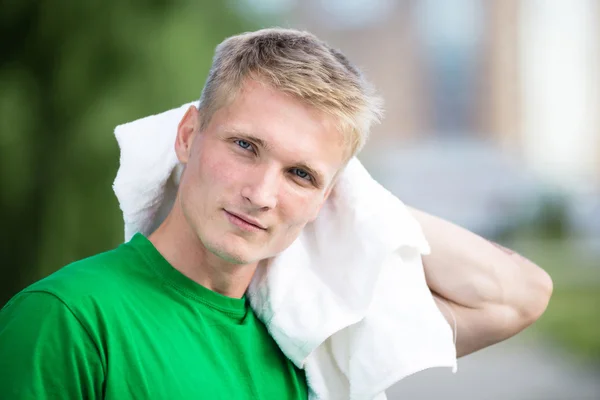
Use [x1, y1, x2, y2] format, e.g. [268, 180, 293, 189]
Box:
[286, 0, 600, 184]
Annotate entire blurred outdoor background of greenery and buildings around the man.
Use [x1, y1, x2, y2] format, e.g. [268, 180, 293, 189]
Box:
[0, 0, 600, 400]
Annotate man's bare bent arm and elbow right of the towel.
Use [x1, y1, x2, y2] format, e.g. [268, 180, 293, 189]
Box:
[411, 209, 552, 357]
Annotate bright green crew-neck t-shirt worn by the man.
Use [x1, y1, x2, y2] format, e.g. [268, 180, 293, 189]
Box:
[0, 234, 308, 400]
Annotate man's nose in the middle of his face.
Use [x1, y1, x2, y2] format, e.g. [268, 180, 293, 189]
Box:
[241, 166, 281, 211]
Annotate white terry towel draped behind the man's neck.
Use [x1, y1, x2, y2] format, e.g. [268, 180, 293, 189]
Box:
[113, 102, 456, 400]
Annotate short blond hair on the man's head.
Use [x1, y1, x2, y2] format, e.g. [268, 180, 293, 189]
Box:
[199, 28, 383, 156]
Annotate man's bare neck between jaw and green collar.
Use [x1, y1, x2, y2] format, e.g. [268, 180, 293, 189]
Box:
[148, 201, 257, 298]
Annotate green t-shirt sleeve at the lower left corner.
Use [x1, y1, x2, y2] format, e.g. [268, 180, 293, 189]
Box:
[0, 292, 104, 400]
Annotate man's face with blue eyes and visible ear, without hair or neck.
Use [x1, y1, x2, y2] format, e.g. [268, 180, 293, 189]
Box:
[177, 80, 345, 264]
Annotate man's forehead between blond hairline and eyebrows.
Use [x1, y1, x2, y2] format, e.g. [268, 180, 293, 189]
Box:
[213, 81, 346, 175]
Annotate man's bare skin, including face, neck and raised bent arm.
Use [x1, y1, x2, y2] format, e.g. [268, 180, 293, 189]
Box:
[149, 76, 552, 357]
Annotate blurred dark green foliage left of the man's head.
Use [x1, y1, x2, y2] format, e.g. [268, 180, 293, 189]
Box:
[0, 0, 256, 306]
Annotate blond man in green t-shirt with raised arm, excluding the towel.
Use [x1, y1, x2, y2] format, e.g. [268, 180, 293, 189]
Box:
[0, 30, 551, 399]
